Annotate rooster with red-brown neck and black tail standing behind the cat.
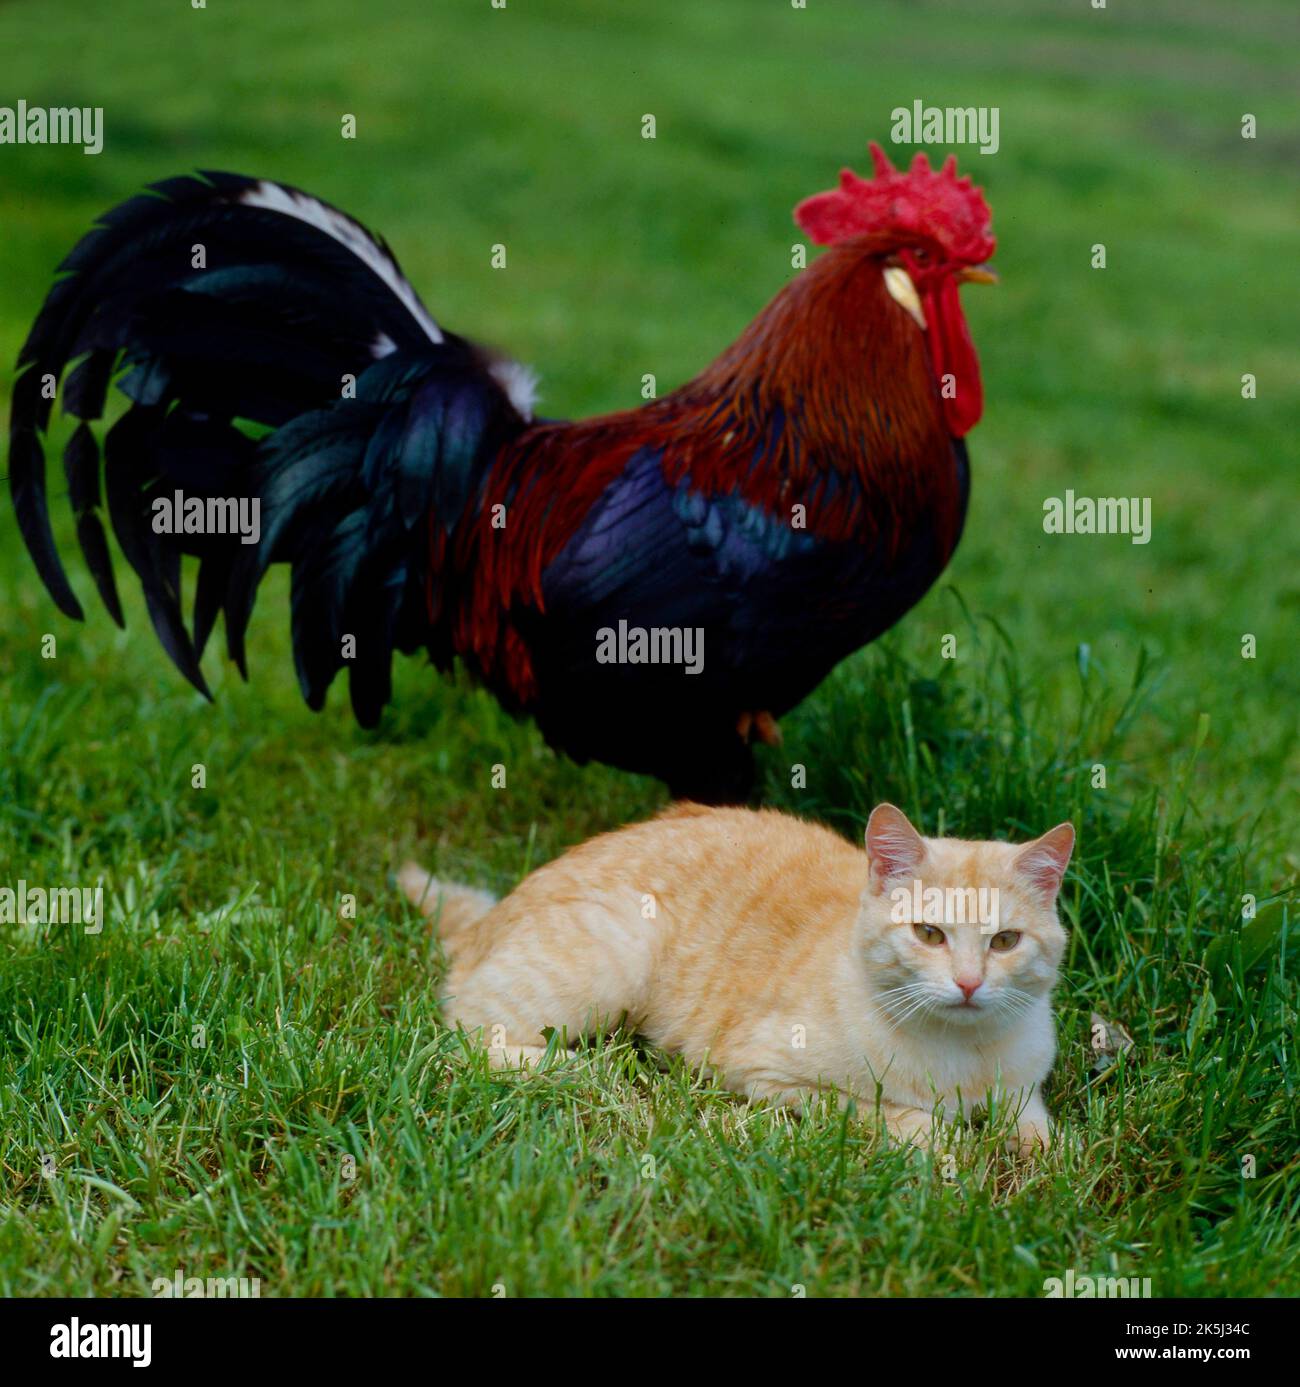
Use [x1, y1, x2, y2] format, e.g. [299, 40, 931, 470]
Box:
[10, 144, 993, 803]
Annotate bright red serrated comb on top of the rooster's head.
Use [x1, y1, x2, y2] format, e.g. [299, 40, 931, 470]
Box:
[795, 140, 995, 265]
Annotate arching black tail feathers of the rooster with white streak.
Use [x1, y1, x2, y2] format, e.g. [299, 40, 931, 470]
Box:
[10, 173, 523, 723]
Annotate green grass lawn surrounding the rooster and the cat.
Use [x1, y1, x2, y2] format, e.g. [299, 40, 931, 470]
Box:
[0, 0, 1300, 1295]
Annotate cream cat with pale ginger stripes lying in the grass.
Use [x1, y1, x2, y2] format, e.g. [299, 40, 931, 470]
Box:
[400, 804, 1074, 1150]
